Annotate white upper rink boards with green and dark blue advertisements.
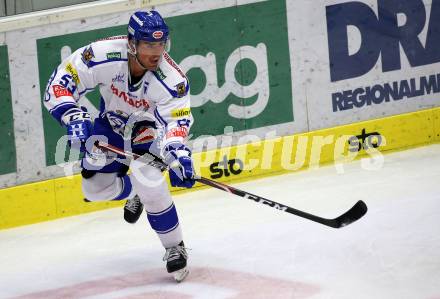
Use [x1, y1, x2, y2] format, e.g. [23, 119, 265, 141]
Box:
[0, 0, 440, 188]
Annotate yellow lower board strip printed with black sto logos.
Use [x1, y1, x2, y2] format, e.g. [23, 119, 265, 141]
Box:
[0, 108, 440, 229]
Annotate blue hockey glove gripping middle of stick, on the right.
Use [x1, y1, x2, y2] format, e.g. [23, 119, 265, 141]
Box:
[164, 142, 195, 188]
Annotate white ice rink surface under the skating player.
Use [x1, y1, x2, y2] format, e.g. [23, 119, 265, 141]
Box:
[0, 145, 440, 299]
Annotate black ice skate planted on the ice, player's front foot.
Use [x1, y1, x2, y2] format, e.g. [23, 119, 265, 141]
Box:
[163, 241, 189, 282]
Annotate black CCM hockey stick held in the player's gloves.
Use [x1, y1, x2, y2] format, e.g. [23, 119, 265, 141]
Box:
[95, 141, 368, 228]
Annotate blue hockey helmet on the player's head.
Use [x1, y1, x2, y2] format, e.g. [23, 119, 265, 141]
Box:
[128, 10, 169, 42]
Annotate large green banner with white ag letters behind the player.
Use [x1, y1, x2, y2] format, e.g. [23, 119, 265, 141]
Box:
[37, 0, 294, 165]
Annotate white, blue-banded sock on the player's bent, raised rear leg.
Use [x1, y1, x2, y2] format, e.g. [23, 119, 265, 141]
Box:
[82, 173, 132, 201]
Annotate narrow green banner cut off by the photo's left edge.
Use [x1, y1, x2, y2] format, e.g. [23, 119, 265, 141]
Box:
[0, 46, 17, 175]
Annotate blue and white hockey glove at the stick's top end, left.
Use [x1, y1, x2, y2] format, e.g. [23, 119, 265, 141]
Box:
[61, 107, 92, 152]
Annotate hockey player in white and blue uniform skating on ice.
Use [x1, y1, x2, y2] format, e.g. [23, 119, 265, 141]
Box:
[44, 11, 194, 282]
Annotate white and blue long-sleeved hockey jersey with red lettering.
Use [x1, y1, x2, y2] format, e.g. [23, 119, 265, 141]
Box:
[44, 36, 193, 163]
